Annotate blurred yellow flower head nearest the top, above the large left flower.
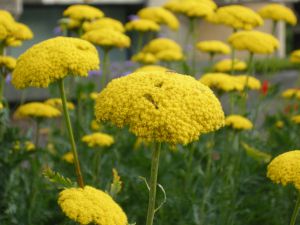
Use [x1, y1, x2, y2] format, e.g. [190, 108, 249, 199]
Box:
[63, 5, 104, 21]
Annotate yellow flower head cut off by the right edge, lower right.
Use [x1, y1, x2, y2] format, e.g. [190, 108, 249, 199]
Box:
[267, 150, 300, 190]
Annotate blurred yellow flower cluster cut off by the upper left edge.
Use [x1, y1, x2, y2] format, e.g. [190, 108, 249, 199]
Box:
[0, 10, 33, 47]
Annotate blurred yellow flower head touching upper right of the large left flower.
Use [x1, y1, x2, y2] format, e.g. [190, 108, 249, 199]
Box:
[82, 28, 130, 48]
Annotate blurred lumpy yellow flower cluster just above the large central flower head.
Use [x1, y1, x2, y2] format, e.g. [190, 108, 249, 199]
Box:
[132, 38, 183, 64]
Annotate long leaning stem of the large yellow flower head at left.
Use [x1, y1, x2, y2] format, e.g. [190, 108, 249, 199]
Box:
[58, 79, 84, 188]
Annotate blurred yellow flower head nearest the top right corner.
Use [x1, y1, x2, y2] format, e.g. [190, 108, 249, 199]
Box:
[258, 3, 297, 25]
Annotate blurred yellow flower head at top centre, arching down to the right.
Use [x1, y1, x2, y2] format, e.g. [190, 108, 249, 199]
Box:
[137, 7, 179, 30]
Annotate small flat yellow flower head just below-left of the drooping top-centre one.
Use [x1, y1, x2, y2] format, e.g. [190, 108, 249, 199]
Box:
[125, 19, 160, 32]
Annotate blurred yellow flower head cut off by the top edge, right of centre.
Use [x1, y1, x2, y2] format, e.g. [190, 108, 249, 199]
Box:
[164, 0, 217, 18]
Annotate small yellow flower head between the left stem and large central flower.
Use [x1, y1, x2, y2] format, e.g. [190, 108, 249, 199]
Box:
[81, 132, 115, 148]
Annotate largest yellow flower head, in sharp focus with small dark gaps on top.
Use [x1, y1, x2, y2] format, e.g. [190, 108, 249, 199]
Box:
[95, 71, 224, 144]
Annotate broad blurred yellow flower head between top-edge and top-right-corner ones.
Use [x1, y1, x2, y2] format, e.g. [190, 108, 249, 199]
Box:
[214, 5, 263, 30]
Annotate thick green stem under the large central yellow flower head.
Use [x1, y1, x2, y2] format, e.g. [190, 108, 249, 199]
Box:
[146, 143, 161, 225]
